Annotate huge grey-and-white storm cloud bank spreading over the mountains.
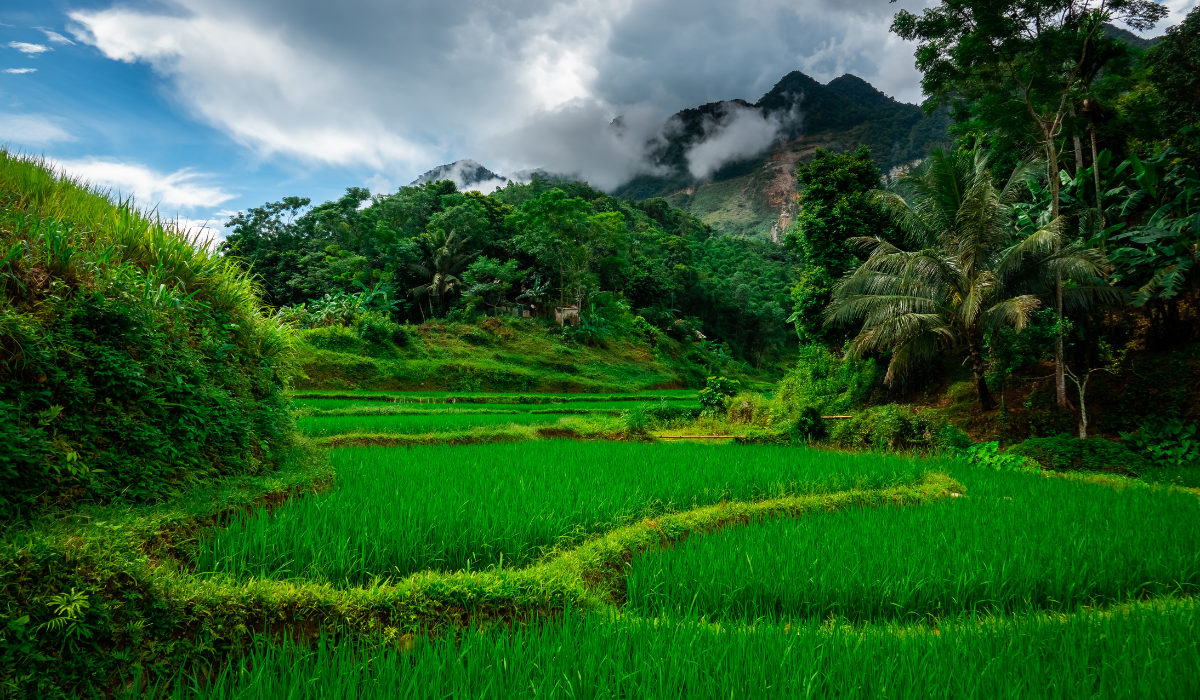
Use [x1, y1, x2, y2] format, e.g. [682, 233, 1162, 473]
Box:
[60, 0, 984, 187]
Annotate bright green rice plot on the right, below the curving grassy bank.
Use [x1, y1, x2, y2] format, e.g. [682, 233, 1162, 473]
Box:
[626, 468, 1200, 622]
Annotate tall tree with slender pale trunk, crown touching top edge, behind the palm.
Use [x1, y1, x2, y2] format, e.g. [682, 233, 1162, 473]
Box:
[892, 0, 1168, 406]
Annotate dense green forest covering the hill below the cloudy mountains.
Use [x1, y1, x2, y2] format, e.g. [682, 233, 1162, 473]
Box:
[222, 177, 793, 366]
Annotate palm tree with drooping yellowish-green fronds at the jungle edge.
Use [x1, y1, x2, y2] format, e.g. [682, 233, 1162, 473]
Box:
[826, 145, 1121, 411]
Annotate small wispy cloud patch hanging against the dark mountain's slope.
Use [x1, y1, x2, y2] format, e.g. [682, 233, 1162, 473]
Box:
[684, 102, 794, 179]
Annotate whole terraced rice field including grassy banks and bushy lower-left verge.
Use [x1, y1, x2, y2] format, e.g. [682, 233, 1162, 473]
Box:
[9, 393, 1200, 700]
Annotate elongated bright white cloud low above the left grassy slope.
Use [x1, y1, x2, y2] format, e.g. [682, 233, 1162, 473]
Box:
[54, 158, 236, 211]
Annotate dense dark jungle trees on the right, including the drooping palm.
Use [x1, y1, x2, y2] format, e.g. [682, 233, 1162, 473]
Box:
[768, 0, 1200, 449]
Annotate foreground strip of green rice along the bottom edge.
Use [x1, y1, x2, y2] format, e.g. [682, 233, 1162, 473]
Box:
[133, 600, 1200, 700]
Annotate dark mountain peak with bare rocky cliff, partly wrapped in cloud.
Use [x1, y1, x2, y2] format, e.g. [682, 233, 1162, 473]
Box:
[613, 71, 949, 240]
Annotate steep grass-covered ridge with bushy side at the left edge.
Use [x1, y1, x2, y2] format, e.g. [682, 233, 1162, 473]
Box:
[0, 149, 293, 520]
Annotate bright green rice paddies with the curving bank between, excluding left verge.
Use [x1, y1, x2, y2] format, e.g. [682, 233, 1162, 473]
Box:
[171, 399, 1200, 700]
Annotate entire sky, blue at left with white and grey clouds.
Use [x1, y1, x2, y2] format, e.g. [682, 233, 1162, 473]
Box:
[0, 0, 1198, 242]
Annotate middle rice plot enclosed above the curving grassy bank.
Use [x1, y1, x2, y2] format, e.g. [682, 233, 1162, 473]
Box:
[197, 441, 930, 584]
